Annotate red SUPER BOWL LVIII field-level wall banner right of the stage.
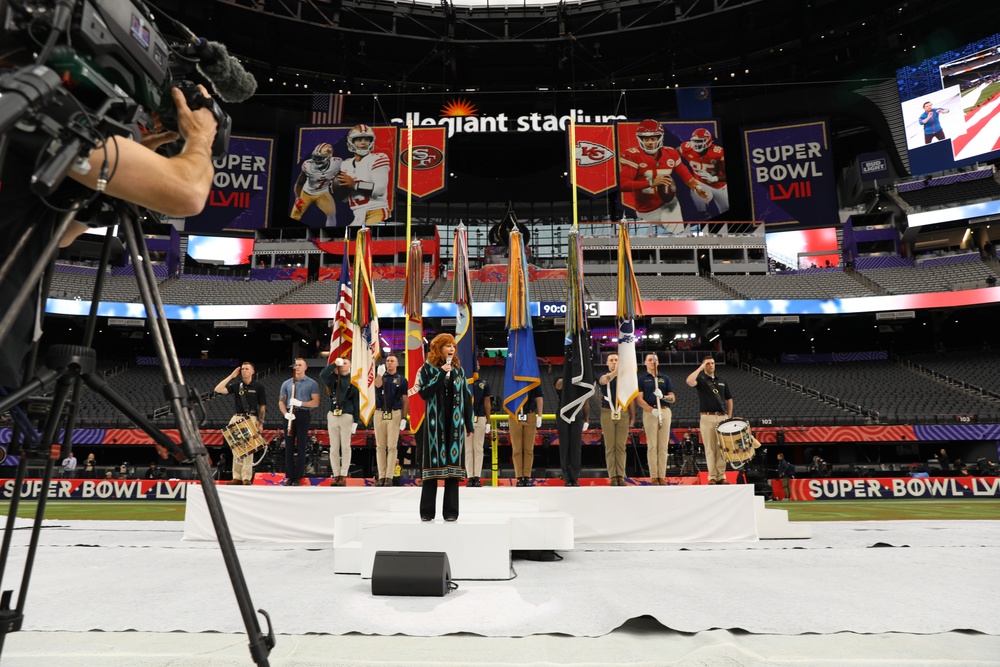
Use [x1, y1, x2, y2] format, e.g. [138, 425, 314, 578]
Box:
[771, 477, 1000, 500]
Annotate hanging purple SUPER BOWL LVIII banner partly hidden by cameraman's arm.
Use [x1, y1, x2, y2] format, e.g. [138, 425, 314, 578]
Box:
[184, 136, 274, 233]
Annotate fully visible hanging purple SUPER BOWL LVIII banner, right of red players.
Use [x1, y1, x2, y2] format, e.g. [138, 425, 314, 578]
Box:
[743, 121, 840, 231]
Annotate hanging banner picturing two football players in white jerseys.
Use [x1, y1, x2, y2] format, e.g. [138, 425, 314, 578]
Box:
[288, 125, 398, 227]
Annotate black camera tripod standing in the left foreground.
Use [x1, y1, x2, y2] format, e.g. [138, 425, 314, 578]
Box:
[0, 200, 275, 666]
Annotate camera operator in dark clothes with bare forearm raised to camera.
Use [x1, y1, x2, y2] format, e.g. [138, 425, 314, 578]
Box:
[0, 52, 217, 387]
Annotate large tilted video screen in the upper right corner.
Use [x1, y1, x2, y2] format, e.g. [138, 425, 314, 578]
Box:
[896, 34, 1000, 175]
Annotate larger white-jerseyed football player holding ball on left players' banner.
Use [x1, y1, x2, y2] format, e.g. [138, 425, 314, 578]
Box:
[333, 125, 389, 225]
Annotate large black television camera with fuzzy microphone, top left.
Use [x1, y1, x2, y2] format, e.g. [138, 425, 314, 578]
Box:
[0, 0, 244, 197]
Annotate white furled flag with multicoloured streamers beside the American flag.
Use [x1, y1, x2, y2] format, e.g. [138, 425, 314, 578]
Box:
[351, 227, 382, 426]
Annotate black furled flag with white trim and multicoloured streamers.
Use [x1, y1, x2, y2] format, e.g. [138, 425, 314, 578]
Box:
[559, 227, 594, 424]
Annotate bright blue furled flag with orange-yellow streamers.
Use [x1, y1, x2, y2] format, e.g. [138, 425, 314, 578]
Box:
[503, 230, 542, 417]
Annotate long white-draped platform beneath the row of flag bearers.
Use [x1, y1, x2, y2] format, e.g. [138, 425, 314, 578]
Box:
[184, 484, 811, 549]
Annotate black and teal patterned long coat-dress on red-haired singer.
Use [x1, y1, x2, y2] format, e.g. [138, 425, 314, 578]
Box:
[417, 363, 473, 479]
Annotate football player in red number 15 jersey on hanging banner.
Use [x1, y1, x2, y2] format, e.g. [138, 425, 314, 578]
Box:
[619, 120, 710, 235]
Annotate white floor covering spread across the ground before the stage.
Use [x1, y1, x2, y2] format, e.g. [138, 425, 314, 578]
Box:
[0, 521, 1000, 667]
